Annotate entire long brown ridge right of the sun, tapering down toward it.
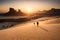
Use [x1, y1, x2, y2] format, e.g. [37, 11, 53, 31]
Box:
[33, 8, 60, 19]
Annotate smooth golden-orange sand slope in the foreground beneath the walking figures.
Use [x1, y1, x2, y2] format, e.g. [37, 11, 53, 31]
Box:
[0, 18, 60, 40]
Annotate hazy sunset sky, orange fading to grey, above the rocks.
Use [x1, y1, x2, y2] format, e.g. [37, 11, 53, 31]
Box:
[0, 0, 60, 12]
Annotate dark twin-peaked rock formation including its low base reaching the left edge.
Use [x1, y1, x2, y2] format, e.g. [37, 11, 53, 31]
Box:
[0, 8, 25, 16]
